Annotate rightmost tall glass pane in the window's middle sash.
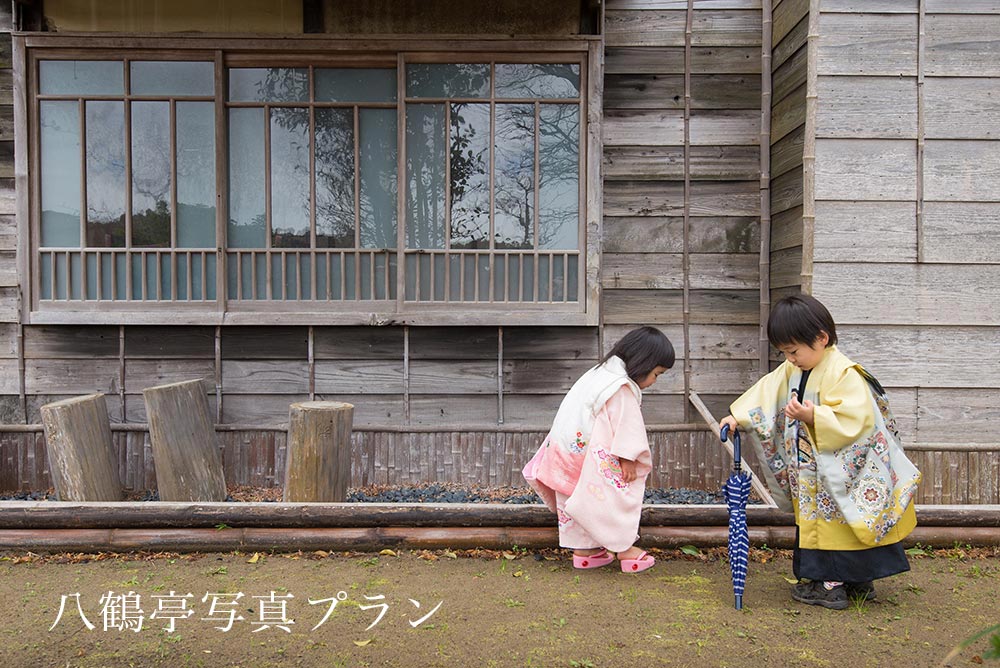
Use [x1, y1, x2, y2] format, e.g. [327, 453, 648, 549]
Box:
[360, 109, 398, 248]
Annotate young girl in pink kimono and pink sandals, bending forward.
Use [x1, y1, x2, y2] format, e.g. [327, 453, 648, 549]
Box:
[523, 327, 674, 573]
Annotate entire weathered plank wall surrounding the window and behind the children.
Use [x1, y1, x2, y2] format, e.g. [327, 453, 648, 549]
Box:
[0, 0, 1000, 503]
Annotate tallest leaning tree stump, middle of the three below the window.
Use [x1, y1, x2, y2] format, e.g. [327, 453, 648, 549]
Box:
[142, 380, 226, 501]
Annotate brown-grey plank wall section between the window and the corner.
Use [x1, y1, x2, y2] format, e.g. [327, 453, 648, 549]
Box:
[601, 0, 761, 423]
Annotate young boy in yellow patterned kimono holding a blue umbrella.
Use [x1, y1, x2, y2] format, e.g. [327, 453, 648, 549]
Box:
[720, 294, 920, 610]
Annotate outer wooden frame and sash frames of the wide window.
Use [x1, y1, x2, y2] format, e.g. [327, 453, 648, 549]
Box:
[13, 34, 603, 325]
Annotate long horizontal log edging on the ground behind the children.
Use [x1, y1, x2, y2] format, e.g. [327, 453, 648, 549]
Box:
[0, 501, 1000, 552]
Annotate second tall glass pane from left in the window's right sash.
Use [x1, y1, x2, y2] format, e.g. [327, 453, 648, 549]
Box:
[448, 104, 490, 248]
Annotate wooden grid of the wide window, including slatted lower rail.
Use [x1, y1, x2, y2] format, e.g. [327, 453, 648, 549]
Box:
[15, 36, 601, 324]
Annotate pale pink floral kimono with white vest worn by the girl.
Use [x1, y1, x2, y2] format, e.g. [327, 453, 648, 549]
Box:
[522, 357, 652, 552]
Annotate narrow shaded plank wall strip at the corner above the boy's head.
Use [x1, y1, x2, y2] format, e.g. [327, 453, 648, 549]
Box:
[770, 0, 809, 294]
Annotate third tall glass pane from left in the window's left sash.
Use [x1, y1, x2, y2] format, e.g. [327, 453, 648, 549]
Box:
[132, 102, 170, 248]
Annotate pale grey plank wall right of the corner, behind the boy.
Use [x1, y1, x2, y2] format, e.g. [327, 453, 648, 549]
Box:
[808, 0, 1000, 460]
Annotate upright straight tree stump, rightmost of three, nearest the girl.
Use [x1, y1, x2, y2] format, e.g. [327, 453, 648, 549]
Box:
[282, 401, 354, 501]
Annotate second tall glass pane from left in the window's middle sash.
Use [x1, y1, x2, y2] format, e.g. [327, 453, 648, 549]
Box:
[271, 108, 311, 248]
